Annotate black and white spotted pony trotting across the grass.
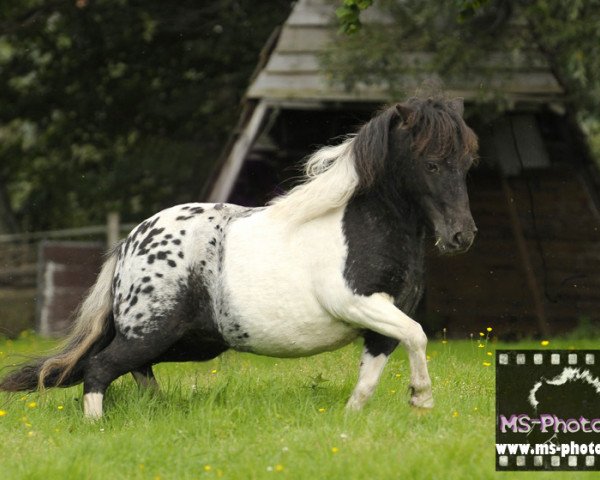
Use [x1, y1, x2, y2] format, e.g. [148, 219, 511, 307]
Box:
[0, 98, 477, 418]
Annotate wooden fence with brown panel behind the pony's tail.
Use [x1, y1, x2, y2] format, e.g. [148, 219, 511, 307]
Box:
[0, 213, 135, 337]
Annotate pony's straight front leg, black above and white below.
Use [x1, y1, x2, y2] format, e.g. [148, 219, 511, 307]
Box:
[346, 331, 398, 410]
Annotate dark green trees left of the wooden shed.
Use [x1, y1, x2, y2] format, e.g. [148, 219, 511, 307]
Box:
[0, 0, 290, 230]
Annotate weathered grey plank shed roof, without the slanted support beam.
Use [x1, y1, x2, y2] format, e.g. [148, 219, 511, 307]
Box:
[247, 0, 563, 103]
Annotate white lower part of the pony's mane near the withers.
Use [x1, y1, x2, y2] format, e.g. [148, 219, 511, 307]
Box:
[269, 137, 358, 224]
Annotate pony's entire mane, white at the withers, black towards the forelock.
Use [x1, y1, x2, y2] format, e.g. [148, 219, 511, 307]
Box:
[269, 97, 477, 225]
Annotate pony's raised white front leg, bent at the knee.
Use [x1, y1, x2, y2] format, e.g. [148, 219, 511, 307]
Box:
[344, 293, 433, 408]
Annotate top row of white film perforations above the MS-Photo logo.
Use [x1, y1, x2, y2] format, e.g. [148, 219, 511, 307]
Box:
[497, 350, 600, 367]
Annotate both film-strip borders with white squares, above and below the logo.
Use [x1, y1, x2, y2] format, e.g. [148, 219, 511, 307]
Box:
[496, 350, 600, 471]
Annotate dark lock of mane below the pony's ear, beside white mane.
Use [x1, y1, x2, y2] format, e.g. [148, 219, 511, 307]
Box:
[352, 106, 399, 190]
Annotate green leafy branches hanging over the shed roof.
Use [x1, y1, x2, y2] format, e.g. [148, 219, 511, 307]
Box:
[326, 0, 600, 116]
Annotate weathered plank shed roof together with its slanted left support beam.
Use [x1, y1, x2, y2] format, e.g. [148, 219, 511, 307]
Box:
[203, 0, 563, 202]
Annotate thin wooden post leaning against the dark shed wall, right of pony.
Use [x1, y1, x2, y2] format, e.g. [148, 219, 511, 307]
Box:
[502, 177, 549, 337]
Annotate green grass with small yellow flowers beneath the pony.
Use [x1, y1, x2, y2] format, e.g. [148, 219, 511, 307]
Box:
[0, 336, 597, 480]
